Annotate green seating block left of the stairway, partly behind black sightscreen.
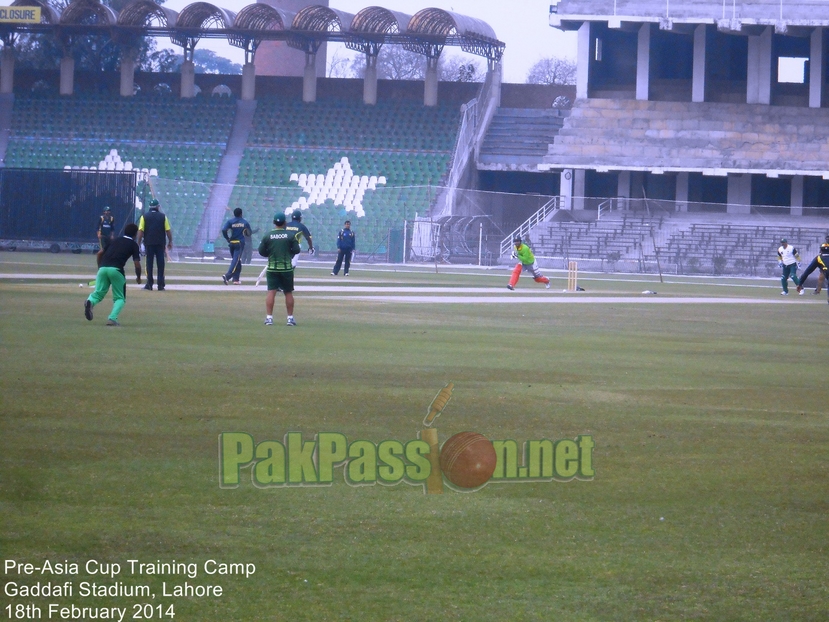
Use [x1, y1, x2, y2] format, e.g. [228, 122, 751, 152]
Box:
[5, 94, 235, 246]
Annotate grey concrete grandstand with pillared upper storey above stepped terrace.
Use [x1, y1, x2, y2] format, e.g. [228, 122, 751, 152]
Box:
[540, 0, 829, 216]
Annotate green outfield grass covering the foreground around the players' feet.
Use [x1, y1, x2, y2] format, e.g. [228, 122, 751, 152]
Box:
[0, 253, 829, 622]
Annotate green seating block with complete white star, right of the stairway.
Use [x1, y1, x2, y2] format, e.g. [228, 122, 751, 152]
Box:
[226, 97, 459, 254]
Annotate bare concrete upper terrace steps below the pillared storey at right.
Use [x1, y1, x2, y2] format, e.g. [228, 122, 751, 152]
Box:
[544, 99, 829, 173]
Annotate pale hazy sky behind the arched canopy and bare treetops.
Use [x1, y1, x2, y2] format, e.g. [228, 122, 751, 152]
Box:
[159, 0, 576, 83]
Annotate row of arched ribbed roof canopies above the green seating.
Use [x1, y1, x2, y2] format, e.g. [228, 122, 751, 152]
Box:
[0, 0, 504, 62]
